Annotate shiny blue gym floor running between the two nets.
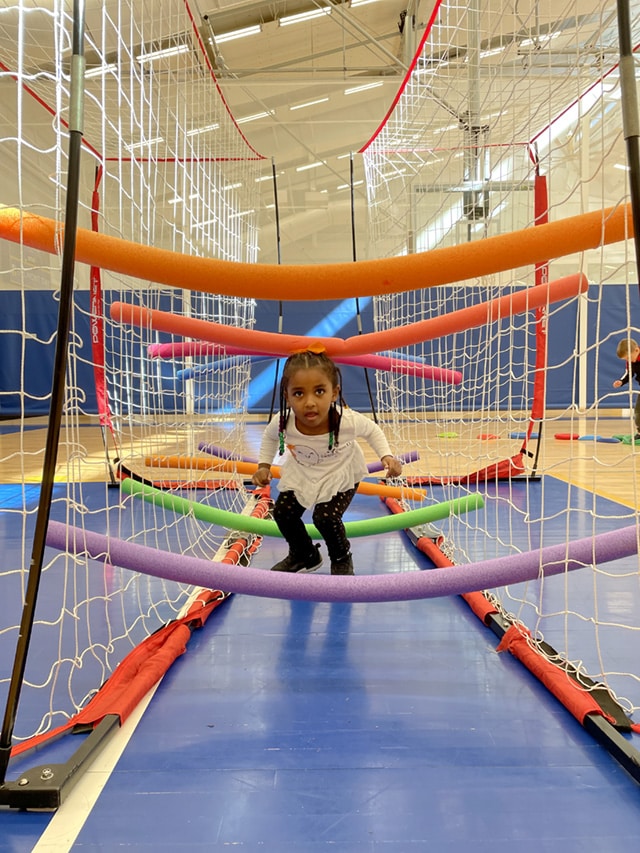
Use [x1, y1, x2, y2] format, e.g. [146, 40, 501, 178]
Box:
[0, 478, 640, 853]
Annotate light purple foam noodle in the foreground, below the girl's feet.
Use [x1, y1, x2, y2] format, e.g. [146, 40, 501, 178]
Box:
[47, 521, 638, 602]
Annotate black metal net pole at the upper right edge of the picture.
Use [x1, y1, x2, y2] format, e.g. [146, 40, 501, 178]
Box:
[618, 0, 640, 296]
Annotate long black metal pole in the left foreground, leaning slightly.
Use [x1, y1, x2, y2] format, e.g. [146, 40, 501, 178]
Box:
[0, 0, 85, 785]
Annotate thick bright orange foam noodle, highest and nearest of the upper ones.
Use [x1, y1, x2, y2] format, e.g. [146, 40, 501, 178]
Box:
[0, 205, 633, 300]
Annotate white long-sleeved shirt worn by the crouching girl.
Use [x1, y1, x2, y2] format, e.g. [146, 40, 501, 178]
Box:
[260, 409, 391, 509]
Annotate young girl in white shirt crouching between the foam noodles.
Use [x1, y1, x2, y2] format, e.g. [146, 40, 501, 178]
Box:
[253, 350, 402, 575]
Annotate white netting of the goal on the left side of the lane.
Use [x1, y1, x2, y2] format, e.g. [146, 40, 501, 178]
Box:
[0, 0, 262, 739]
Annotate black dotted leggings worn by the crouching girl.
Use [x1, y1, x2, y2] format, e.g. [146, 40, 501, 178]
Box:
[273, 490, 358, 563]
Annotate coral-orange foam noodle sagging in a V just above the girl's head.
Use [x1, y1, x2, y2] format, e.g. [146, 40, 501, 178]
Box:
[111, 273, 589, 357]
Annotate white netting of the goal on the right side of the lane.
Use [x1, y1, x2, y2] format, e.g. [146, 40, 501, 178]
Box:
[364, 0, 640, 710]
